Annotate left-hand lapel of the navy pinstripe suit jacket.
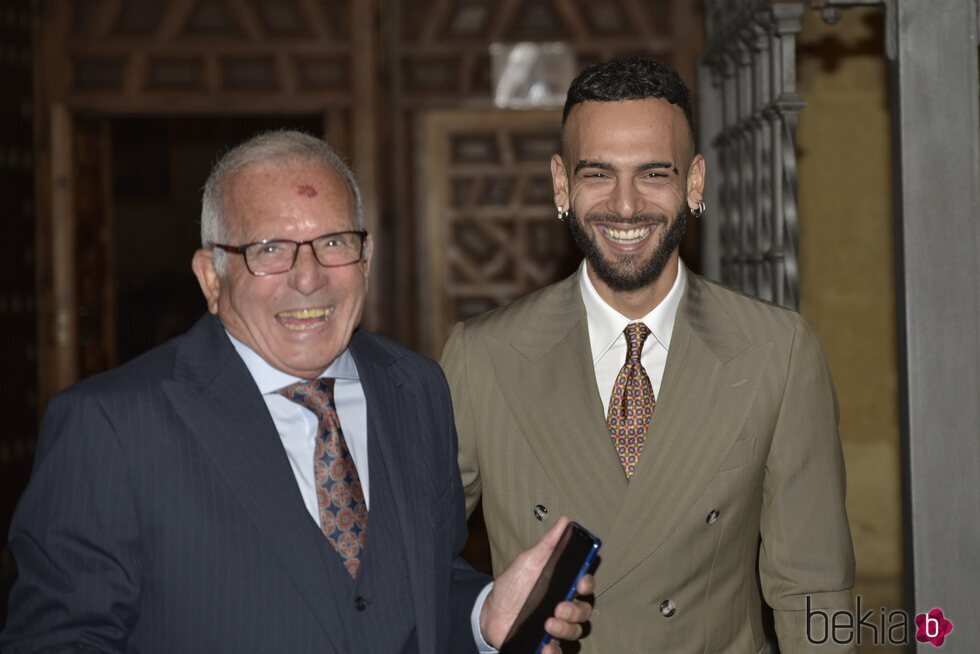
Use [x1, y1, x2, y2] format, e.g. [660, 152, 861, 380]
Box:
[162, 317, 346, 652]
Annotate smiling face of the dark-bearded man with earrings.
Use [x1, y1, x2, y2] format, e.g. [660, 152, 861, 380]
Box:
[551, 98, 704, 291]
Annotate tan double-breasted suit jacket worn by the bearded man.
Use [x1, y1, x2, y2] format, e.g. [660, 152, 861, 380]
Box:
[442, 273, 854, 654]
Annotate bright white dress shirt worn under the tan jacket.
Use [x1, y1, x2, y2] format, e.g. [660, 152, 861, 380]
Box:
[579, 261, 687, 413]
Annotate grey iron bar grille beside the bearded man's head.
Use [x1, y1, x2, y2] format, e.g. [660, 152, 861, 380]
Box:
[699, 0, 804, 309]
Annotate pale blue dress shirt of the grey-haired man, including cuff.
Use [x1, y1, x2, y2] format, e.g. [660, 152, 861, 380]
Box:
[225, 331, 497, 654]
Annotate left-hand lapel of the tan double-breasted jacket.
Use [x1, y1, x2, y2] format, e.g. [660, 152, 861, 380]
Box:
[487, 274, 627, 533]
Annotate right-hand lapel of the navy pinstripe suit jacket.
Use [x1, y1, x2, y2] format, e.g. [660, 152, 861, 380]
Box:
[350, 332, 436, 652]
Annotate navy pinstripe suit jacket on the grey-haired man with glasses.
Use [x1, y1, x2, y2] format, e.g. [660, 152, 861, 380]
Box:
[0, 317, 487, 654]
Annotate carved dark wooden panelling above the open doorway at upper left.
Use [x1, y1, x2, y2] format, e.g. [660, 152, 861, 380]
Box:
[46, 0, 358, 113]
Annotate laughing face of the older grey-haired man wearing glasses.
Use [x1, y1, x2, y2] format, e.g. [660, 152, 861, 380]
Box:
[194, 163, 371, 379]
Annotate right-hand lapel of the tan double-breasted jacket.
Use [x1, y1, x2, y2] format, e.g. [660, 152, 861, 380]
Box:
[596, 273, 770, 594]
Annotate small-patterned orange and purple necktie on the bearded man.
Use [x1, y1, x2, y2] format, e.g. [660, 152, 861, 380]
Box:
[606, 322, 657, 479]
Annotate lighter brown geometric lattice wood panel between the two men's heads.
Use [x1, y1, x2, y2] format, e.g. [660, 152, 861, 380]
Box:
[421, 110, 579, 353]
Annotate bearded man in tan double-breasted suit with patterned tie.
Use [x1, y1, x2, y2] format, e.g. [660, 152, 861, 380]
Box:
[443, 58, 854, 654]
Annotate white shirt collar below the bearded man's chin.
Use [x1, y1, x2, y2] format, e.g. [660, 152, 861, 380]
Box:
[579, 260, 687, 365]
